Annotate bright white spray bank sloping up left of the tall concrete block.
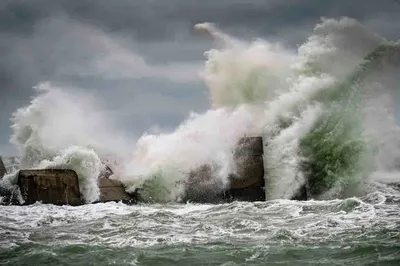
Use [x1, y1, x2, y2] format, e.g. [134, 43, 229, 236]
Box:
[120, 106, 255, 201]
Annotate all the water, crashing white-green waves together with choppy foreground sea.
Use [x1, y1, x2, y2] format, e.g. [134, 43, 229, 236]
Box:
[0, 18, 400, 265]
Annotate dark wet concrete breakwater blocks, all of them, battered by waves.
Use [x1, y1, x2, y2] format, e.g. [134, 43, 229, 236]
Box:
[0, 137, 265, 205]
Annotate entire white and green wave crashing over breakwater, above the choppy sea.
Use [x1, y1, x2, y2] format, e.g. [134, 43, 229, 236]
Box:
[3, 18, 400, 202]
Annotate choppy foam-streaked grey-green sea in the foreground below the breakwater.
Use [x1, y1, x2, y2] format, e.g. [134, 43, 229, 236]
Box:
[0, 192, 400, 265]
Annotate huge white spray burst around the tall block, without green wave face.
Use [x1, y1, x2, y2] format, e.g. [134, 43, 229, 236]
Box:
[118, 18, 382, 199]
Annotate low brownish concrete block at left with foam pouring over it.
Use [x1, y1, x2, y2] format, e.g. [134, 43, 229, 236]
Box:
[18, 169, 83, 205]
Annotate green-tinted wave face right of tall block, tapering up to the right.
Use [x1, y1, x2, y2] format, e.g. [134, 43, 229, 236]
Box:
[300, 45, 395, 196]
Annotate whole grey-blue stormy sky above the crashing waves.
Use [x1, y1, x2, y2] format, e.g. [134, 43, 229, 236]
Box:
[0, 0, 400, 155]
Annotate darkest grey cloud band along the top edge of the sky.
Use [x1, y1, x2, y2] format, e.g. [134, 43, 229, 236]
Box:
[1, 0, 400, 41]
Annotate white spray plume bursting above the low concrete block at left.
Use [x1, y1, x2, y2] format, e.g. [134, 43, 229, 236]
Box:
[7, 83, 130, 202]
